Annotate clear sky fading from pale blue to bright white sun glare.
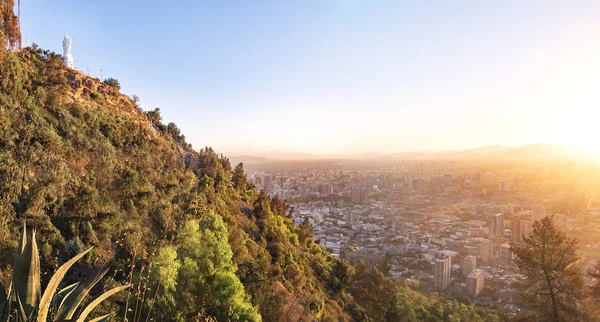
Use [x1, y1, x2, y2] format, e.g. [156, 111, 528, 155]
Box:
[21, 0, 600, 155]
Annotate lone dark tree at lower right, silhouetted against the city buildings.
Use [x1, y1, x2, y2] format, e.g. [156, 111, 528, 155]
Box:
[513, 216, 583, 322]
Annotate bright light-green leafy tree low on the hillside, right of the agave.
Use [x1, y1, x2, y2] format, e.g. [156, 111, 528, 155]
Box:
[176, 212, 261, 321]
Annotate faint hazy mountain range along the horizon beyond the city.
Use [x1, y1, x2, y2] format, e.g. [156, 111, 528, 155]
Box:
[229, 143, 584, 164]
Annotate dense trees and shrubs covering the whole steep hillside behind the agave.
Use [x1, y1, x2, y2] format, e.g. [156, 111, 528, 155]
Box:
[0, 47, 502, 321]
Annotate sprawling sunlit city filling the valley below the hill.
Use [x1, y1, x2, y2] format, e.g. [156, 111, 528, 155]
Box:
[246, 163, 600, 312]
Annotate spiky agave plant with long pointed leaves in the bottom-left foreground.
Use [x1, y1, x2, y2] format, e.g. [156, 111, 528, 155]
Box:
[0, 224, 129, 322]
